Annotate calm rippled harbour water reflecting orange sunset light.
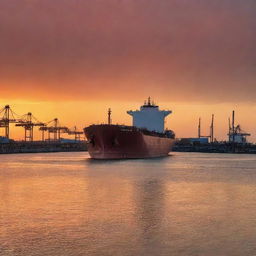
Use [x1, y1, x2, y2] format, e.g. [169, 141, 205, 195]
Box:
[0, 153, 256, 256]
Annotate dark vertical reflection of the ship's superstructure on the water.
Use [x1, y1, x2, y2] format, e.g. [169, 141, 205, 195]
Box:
[134, 178, 165, 255]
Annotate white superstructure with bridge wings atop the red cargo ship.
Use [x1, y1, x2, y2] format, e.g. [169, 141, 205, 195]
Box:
[127, 98, 172, 132]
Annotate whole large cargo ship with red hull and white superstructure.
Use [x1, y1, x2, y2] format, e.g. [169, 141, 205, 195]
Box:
[84, 98, 175, 159]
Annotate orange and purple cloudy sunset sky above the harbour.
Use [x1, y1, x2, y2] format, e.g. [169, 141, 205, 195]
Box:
[0, 0, 256, 141]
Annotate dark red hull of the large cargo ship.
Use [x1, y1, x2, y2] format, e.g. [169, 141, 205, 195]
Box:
[84, 125, 175, 159]
